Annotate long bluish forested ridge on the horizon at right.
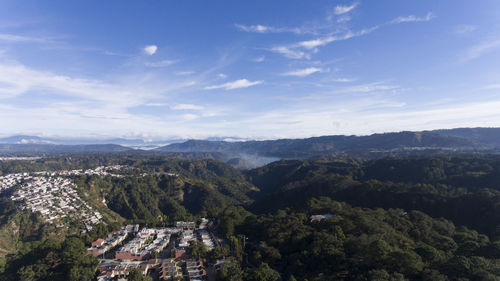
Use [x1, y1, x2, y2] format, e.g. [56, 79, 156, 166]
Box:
[157, 128, 500, 158]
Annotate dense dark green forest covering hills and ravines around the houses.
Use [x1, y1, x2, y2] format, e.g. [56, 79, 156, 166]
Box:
[0, 154, 500, 280]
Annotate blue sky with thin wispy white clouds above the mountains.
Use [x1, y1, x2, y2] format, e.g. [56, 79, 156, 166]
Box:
[0, 0, 500, 139]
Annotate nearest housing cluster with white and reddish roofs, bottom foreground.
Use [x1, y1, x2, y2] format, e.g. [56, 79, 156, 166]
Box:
[96, 219, 218, 281]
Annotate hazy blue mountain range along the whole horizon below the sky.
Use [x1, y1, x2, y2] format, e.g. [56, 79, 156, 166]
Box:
[0, 128, 500, 168]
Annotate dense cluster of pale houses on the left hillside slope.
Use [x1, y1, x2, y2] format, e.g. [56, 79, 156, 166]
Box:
[10, 176, 102, 230]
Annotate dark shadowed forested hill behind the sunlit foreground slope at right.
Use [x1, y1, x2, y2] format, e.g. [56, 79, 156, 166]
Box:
[246, 156, 500, 237]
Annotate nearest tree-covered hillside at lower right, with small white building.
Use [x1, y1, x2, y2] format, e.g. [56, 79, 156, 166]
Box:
[226, 198, 499, 281]
